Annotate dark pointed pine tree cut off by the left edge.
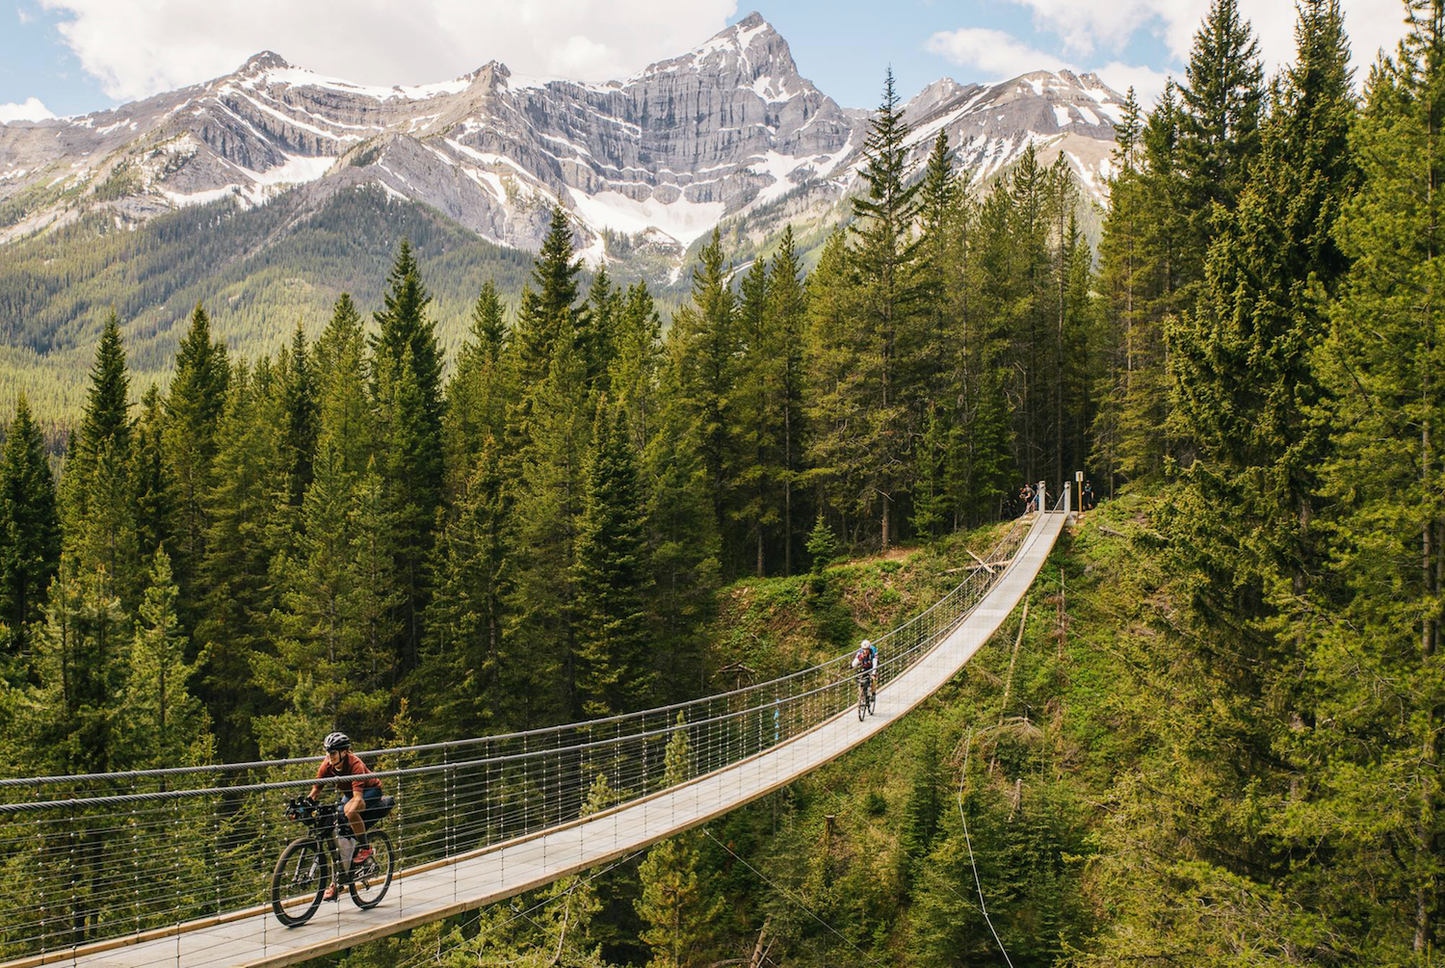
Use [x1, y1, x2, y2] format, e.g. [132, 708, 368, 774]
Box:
[0, 393, 61, 678]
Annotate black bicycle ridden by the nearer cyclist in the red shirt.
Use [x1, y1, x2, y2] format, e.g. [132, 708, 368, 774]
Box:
[270, 796, 396, 928]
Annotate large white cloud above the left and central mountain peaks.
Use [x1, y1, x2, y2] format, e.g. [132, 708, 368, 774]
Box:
[40, 0, 737, 100]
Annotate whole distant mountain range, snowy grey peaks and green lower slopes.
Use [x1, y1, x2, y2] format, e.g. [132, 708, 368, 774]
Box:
[0, 13, 1121, 413]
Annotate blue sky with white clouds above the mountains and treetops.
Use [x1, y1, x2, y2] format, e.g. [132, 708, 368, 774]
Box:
[0, 0, 1405, 123]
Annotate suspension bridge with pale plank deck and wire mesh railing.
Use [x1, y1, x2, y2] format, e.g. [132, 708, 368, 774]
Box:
[0, 484, 1071, 968]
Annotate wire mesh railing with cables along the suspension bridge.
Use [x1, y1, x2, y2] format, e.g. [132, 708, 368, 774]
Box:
[0, 516, 1051, 959]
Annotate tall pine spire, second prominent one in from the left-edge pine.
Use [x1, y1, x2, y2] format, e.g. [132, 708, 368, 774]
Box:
[162, 303, 231, 628]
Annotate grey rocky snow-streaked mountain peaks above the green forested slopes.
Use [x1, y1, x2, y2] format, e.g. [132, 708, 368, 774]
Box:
[0, 13, 1121, 262]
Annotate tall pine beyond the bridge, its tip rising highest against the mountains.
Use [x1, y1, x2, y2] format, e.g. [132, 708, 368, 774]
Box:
[850, 68, 919, 550]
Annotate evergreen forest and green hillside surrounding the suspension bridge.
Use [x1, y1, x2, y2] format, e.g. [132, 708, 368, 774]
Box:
[0, 0, 1445, 968]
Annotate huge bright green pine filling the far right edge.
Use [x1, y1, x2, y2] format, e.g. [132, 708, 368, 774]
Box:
[1312, 0, 1445, 964]
